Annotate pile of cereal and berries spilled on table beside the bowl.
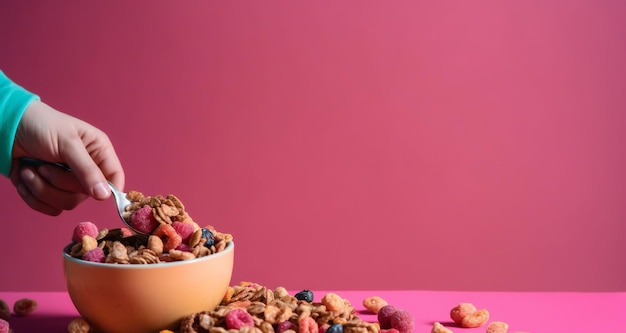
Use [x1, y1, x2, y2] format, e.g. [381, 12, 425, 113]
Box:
[171, 282, 413, 333]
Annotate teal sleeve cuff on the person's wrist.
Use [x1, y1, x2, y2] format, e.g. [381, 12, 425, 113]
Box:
[0, 70, 39, 176]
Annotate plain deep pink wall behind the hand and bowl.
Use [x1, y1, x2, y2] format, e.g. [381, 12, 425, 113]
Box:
[0, 0, 626, 291]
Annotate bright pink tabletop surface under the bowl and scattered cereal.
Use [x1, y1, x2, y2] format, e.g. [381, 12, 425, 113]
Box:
[0, 290, 626, 333]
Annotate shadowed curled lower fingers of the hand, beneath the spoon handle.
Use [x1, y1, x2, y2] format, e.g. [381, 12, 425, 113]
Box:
[12, 166, 87, 216]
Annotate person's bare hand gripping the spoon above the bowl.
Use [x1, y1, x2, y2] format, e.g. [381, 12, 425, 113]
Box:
[10, 101, 124, 215]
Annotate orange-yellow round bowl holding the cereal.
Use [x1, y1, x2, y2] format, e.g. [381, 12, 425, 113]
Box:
[63, 242, 235, 333]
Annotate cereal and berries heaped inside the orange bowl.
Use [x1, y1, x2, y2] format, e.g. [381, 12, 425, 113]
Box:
[69, 191, 233, 264]
